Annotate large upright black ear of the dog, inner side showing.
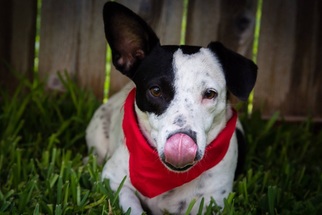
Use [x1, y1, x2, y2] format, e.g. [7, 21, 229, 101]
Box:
[103, 2, 159, 78]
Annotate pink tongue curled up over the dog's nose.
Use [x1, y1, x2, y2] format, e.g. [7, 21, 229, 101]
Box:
[164, 133, 197, 168]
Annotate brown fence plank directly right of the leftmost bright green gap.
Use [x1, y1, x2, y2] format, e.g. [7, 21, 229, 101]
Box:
[39, 0, 80, 90]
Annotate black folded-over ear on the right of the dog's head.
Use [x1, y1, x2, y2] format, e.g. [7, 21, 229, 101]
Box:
[208, 42, 257, 101]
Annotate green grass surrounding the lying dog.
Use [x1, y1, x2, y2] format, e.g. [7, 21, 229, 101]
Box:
[0, 74, 322, 215]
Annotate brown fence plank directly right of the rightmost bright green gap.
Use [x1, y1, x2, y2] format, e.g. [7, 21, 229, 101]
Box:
[254, 0, 296, 118]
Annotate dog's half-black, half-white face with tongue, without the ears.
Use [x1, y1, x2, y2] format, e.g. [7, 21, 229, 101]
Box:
[134, 46, 227, 171]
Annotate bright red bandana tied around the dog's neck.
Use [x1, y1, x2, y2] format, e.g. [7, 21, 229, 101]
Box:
[123, 89, 237, 198]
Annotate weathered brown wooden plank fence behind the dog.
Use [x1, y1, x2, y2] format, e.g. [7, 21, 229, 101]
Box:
[0, 0, 322, 121]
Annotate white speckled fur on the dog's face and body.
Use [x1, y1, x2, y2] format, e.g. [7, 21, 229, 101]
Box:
[86, 48, 238, 214]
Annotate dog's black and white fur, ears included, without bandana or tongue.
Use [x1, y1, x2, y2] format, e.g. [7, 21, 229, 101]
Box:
[86, 2, 257, 214]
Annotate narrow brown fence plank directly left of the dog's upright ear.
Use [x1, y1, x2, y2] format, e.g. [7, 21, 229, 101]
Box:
[77, 0, 107, 99]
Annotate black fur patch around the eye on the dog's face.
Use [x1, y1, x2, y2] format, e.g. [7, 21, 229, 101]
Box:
[132, 46, 200, 115]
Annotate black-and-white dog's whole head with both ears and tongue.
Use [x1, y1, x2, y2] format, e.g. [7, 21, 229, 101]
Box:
[103, 2, 257, 171]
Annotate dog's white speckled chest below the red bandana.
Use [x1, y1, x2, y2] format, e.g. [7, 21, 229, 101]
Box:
[140, 154, 236, 214]
